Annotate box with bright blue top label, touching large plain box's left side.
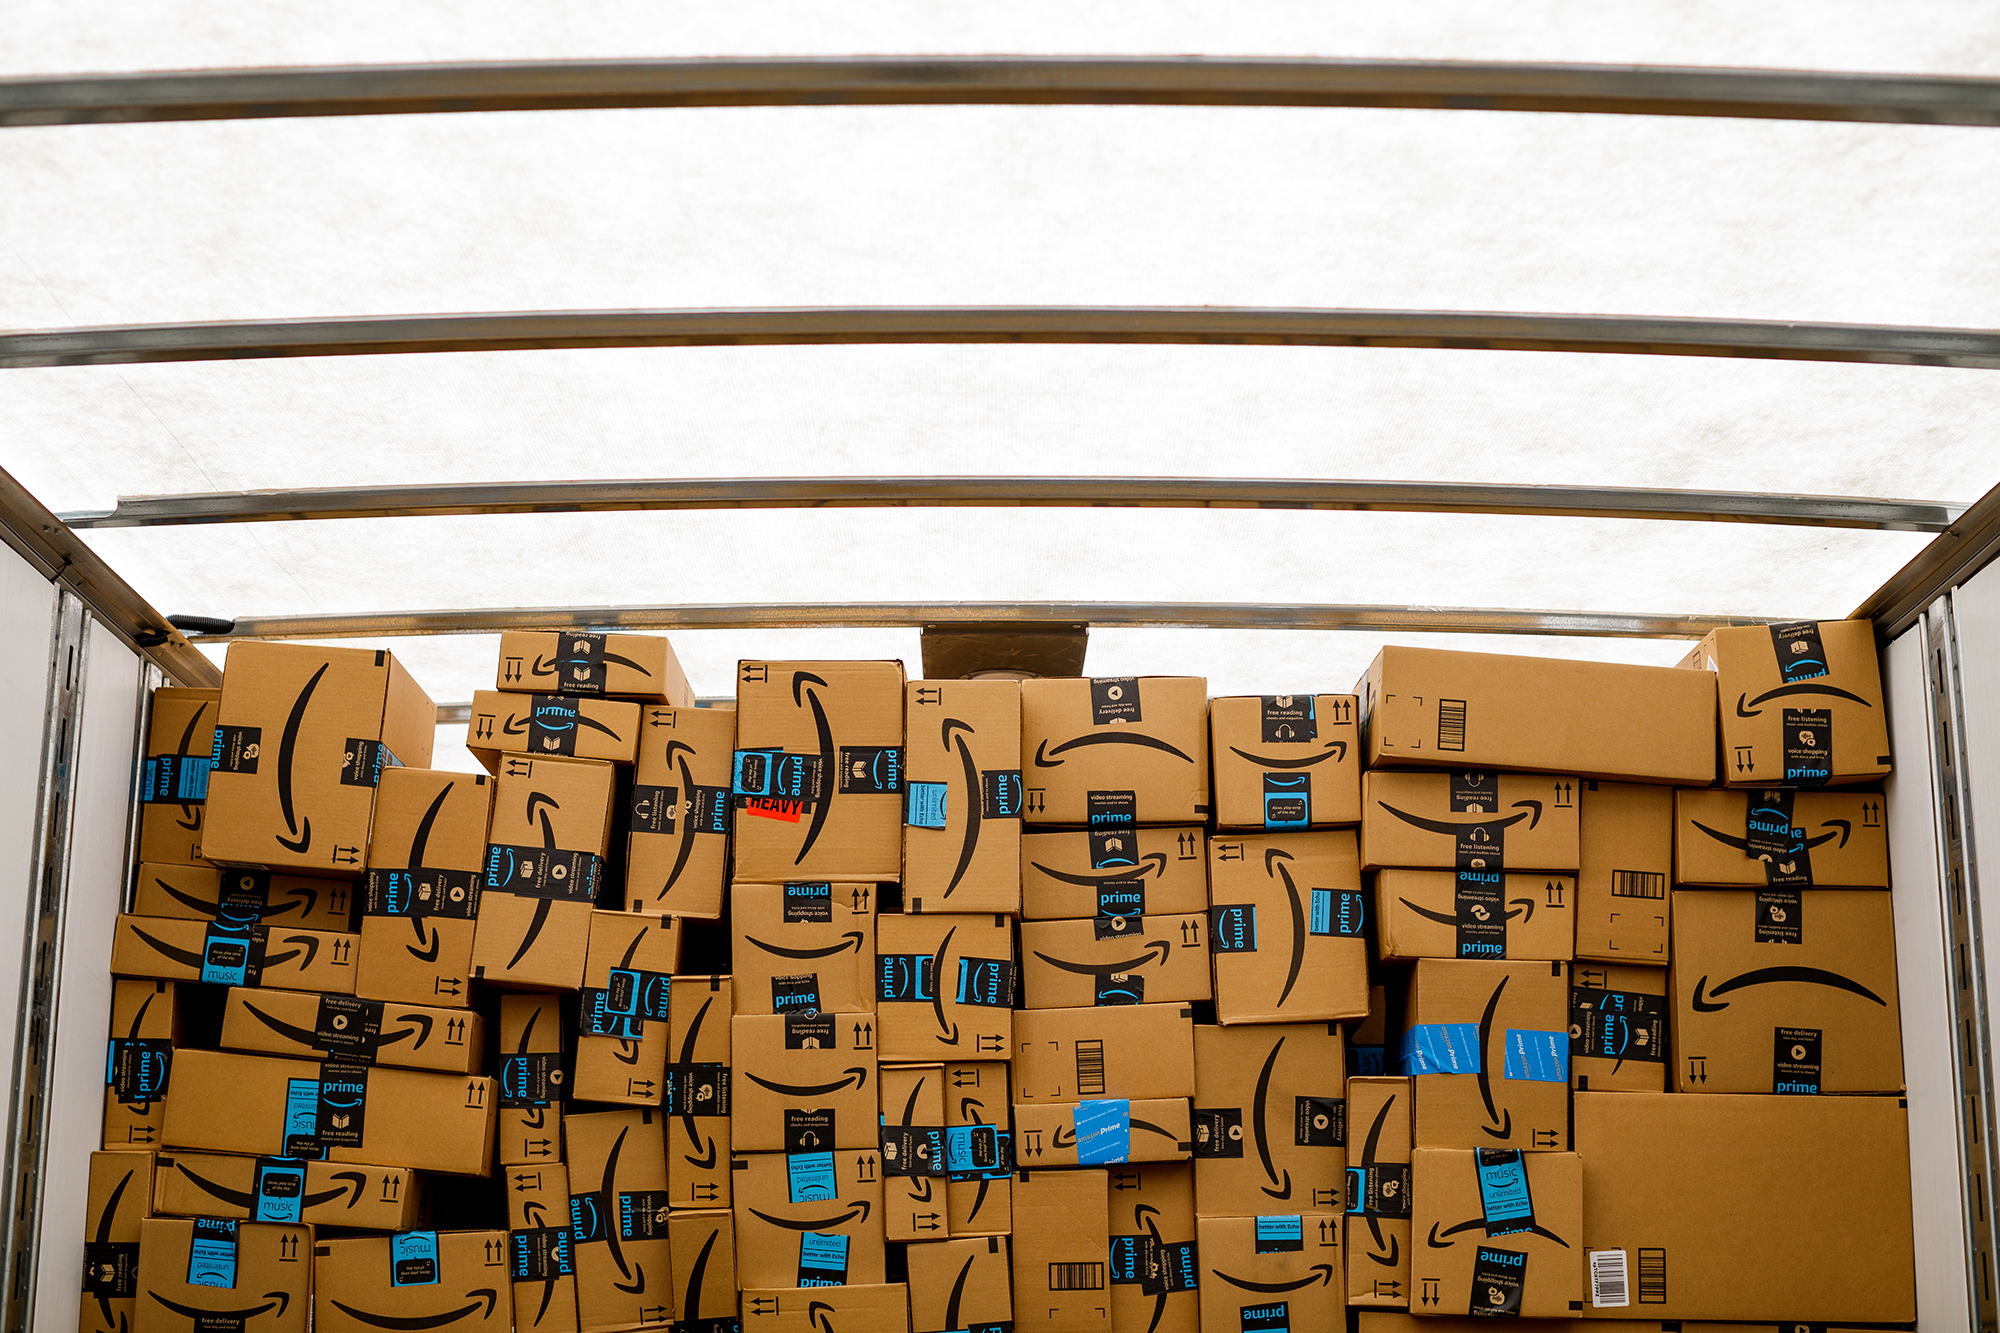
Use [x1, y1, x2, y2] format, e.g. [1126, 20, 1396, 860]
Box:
[1410, 1149, 1584, 1319]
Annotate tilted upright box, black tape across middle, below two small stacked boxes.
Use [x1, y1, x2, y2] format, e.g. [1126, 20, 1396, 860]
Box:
[472, 755, 616, 991]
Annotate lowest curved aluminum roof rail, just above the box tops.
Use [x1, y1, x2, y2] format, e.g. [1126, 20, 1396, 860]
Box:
[196, 602, 1766, 642]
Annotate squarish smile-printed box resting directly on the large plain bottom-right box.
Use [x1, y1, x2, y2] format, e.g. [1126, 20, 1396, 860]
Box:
[1668, 889, 1902, 1093]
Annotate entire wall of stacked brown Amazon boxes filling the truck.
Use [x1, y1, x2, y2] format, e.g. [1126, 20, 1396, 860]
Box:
[84, 622, 1914, 1333]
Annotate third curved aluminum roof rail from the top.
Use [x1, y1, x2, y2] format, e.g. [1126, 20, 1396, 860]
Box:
[60, 476, 1966, 532]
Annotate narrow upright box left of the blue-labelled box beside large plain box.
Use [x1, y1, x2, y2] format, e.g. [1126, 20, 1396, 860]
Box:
[1346, 1079, 1410, 1309]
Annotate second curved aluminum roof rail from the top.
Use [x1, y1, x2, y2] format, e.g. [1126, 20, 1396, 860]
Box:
[11, 306, 2000, 370]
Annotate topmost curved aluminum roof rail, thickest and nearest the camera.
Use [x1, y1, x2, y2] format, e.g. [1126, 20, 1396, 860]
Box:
[0, 56, 2000, 126]
